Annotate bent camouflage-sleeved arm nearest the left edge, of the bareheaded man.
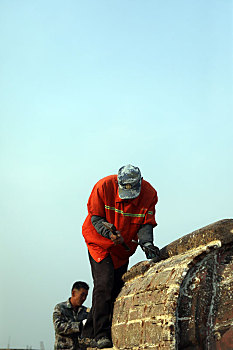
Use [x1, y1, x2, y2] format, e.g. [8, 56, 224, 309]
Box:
[53, 305, 82, 335]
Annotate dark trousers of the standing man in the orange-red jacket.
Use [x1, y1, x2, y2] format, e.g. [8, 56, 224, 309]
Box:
[82, 254, 128, 339]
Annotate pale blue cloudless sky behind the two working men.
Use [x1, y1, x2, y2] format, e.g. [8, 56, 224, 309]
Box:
[0, 0, 233, 350]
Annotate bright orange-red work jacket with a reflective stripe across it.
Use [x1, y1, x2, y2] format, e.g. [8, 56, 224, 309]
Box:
[82, 175, 158, 268]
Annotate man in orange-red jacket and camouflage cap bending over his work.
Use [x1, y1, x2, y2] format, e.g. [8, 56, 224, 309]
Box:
[82, 165, 159, 349]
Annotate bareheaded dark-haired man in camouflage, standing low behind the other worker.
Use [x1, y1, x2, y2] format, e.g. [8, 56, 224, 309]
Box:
[53, 281, 90, 350]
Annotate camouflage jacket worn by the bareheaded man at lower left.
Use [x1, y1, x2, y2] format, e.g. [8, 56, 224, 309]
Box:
[53, 299, 90, 350]
